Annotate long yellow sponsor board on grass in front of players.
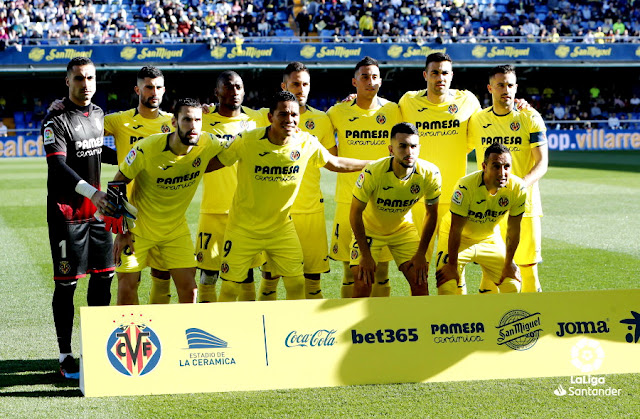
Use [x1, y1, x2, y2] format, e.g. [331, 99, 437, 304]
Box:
[80, 290, 640, 397]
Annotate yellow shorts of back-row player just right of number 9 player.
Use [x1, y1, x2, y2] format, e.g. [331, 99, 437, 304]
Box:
[262, 211, 330, 275]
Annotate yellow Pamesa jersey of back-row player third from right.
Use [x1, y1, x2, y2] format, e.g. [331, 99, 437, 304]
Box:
[327, 97, 402, 204]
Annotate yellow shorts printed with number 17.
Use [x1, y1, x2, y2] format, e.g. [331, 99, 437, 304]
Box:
[196, 214, 264, 270]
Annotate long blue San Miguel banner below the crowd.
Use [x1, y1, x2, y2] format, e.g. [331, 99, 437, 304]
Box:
[0, 42, 640, 67]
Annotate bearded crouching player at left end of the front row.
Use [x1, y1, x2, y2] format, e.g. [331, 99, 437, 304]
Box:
[113, 99, 224, 305]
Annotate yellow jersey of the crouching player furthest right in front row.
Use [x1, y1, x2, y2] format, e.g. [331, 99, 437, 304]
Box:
[441, 170, 527, 242]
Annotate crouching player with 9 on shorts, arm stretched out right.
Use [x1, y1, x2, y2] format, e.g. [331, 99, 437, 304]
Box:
[212, 91, 367, 301]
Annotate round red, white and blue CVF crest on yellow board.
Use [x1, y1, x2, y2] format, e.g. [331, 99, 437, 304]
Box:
[107, 314, 162, 377]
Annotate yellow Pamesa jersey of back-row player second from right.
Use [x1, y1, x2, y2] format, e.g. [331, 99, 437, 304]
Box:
[398, 89, 480, 204]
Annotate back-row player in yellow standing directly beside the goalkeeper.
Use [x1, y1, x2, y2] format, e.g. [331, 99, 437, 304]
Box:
[104, 66, 173, 304]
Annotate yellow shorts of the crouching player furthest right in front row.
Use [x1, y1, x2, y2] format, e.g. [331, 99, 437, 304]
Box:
[436, 231, 506, 290]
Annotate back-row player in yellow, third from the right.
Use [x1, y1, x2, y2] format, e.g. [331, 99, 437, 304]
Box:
[327, 57, 402, 298]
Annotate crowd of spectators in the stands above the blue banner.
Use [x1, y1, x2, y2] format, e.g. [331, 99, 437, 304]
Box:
[0, 0, 640, 46]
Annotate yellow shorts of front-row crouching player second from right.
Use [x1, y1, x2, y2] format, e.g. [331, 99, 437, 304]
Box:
[349, 225, 420, 266]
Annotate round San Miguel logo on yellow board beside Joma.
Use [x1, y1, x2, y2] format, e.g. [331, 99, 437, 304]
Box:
[496, 310, 542, 351]
